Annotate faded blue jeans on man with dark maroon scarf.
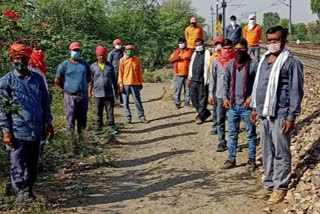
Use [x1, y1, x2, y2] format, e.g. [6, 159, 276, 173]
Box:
[228, 105, 256, 161]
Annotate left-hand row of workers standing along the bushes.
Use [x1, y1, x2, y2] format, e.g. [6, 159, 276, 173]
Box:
[0, 39, 148, 204]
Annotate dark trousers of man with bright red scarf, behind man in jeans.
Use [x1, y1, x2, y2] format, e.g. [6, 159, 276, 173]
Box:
[216, 98, 227, 145]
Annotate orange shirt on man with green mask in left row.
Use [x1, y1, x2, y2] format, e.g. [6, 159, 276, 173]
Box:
[118, 56, 143, 86]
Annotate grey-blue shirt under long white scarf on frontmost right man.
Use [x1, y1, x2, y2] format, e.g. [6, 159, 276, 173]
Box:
[256, 54, 304, 121]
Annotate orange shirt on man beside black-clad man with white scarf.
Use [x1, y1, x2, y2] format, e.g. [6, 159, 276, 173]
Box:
[169, 48, 192, 76]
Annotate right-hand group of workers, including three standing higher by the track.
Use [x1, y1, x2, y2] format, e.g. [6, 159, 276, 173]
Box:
[169, 15, 304, 204]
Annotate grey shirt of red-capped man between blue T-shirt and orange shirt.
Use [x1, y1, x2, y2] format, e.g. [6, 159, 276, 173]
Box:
[90, 62, 117, 97]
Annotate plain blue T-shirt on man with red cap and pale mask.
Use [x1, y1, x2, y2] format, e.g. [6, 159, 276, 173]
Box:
[56, 60, 91, 93]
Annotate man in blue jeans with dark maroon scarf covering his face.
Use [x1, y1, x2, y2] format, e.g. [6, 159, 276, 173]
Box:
[223, 39, 258, 172]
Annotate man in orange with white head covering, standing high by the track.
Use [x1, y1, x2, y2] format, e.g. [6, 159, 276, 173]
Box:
[243, 15, 262, 61]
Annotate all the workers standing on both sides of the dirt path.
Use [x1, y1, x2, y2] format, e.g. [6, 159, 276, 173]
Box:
[0, 15, 303, 207]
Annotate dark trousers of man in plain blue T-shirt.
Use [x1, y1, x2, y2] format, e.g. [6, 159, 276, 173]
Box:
[64, 93, 88, 134]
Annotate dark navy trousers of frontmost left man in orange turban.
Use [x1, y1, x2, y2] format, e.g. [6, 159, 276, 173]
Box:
[11, 139, 40, 194]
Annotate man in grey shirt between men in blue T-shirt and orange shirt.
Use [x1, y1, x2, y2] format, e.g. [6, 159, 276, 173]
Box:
[88, 46, 118, 131]
